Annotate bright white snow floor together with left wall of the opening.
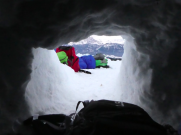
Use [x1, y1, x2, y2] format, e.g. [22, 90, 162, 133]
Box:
[26, 48, 121, 115]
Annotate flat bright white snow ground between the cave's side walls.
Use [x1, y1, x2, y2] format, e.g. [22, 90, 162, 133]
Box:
[70, 61, 121, 100]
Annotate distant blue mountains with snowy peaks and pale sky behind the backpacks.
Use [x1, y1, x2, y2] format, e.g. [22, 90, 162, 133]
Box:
[68, 35, 125, 57]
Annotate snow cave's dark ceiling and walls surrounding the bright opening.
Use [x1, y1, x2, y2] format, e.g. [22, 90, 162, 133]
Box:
[0, 0, 181, 135]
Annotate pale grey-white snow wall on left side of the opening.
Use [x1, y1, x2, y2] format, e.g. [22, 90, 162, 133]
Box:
[25, 48, 76, 115]
